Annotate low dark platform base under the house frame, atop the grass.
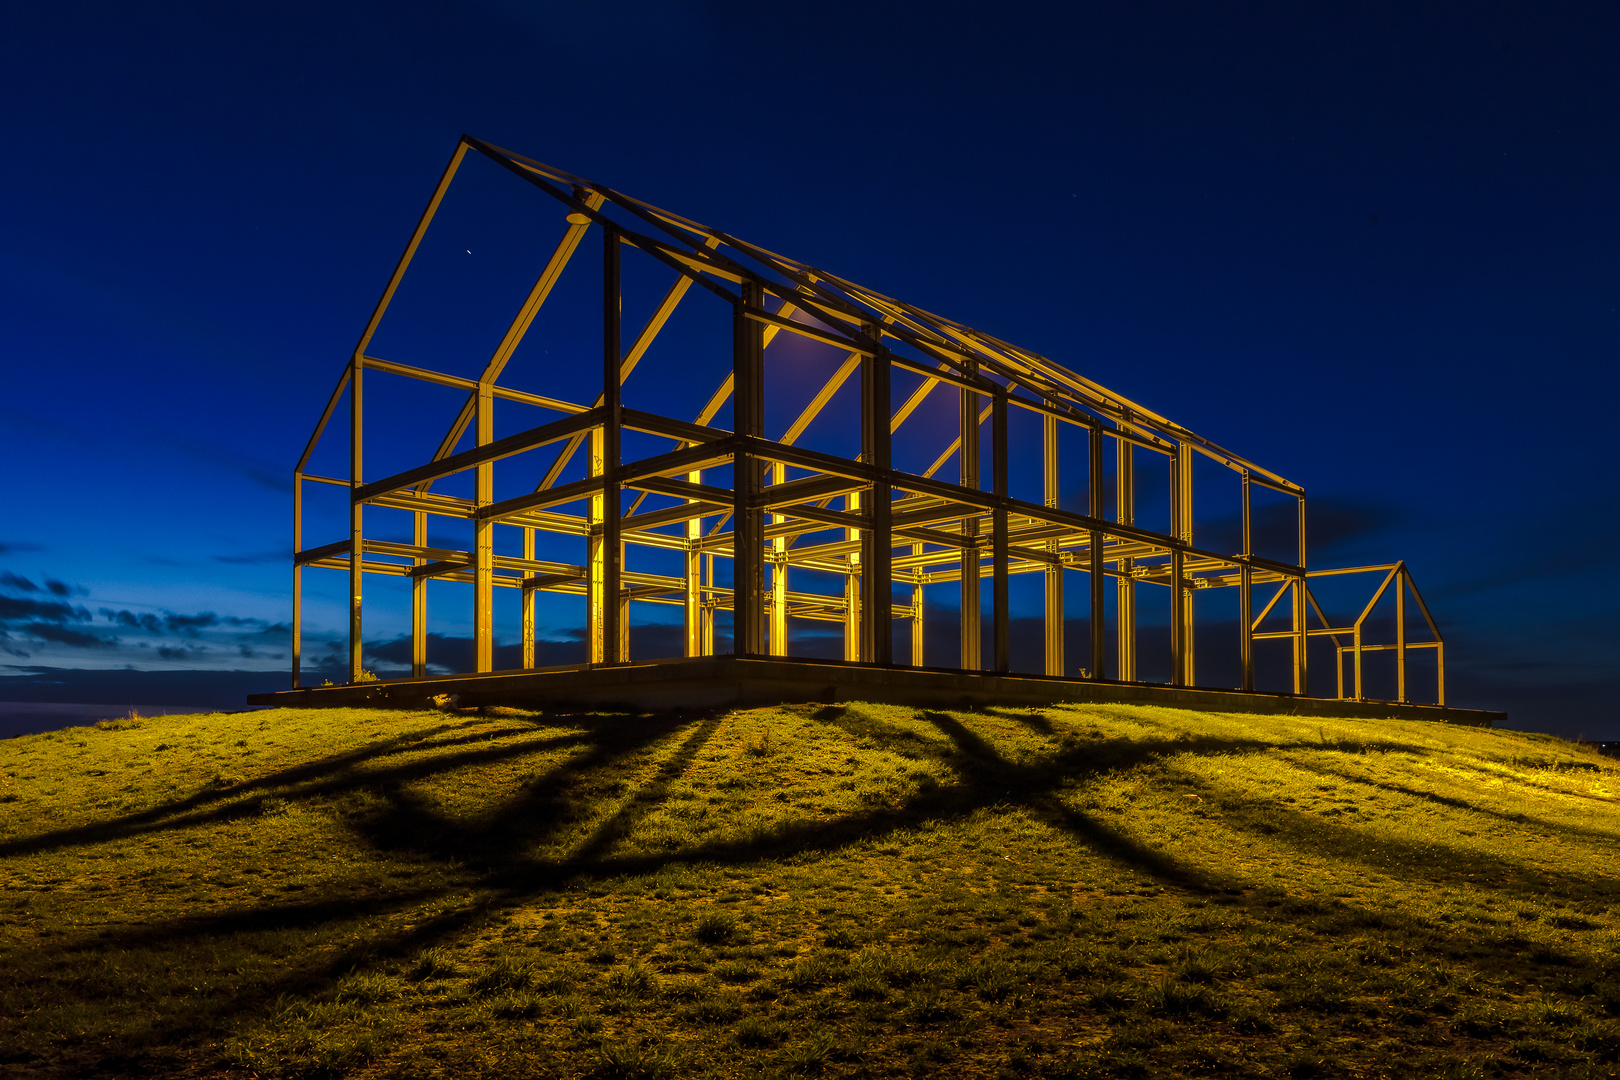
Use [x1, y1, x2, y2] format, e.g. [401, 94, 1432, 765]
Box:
[248, 656, 1507, 727]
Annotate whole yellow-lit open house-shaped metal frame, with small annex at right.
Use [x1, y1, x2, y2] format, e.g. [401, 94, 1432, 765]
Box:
[293, 136, 1445, 704]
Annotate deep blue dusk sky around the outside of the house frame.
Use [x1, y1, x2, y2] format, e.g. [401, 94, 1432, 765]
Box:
[0, 2, 1620, 738]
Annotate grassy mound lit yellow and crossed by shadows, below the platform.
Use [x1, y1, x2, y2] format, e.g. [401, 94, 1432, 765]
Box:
[0, 704, 1620, 1080]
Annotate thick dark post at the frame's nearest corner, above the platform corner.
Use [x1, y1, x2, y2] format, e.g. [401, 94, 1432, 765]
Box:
[731, 279, 765, 656]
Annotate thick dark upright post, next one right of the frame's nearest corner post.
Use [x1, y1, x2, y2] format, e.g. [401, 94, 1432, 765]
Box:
[860, 324, 894, 664]
